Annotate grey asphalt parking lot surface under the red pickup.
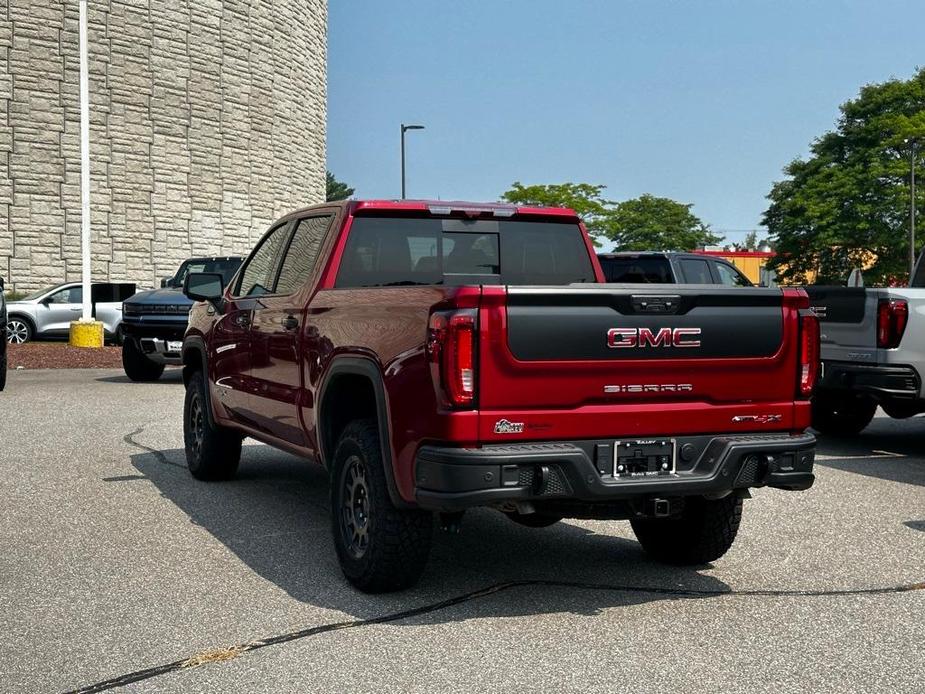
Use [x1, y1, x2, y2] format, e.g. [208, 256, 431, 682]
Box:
[0, 370, 925, 692]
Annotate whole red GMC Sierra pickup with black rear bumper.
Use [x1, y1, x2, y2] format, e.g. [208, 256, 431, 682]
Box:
[183, 201, 818, 591]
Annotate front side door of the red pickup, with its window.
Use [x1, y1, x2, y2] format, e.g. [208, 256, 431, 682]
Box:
[211, 221, 291, 426]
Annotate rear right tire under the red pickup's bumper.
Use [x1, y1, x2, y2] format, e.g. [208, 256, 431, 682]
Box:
[630, 494, 742, 566]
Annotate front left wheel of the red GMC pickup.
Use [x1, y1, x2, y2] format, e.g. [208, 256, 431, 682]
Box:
[183, 371, 242, 482]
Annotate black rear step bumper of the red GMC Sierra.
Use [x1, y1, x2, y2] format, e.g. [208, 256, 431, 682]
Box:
[415, 434, 816, 511]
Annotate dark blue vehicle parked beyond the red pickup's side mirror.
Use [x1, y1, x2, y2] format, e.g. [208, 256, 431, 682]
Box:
[122, 256, 242, 381]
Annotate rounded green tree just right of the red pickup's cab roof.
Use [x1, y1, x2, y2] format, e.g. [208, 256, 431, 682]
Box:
[604, 193, 722, 251]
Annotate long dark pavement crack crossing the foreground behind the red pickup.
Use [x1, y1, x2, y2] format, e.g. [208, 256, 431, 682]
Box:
[69, 579, 925, 694]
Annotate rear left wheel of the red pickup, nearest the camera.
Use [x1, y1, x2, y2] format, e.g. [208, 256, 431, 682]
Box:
[331, 419, 434, 593]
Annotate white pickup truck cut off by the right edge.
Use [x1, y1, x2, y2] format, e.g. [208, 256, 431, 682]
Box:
[806, 254, 925, 436]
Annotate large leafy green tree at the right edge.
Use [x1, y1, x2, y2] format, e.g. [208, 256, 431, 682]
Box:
[762, 69, 925, 285]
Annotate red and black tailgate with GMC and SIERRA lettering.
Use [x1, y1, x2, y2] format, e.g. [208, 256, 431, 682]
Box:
[479, 285, 806, 440]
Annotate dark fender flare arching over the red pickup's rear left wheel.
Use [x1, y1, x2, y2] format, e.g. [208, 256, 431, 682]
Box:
[315, 355, 411, 508]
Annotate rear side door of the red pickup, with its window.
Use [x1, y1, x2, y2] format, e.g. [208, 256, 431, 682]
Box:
[250, 213, 332, 447]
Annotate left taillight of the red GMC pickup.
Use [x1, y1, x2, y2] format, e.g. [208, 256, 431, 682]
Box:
[427, 310, 476, 407]
